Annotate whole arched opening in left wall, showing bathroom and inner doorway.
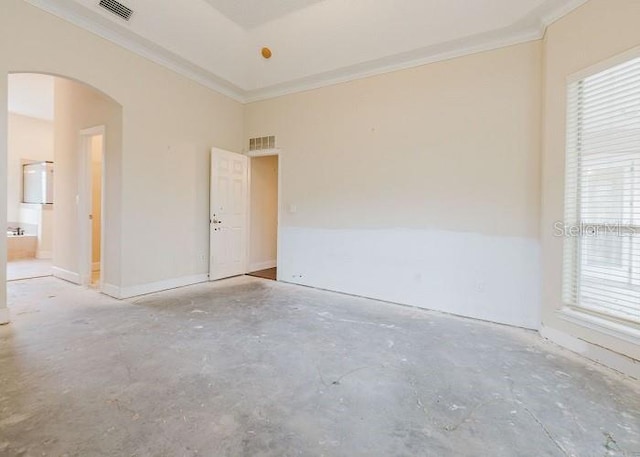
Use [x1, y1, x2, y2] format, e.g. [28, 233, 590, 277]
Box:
[2, 73, 122, 300]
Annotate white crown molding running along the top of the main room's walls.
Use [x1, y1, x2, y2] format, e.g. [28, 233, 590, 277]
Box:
[25, 0, 588, 103]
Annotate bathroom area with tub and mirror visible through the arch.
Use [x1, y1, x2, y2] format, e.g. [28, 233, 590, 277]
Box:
[6, 73, 54, 281]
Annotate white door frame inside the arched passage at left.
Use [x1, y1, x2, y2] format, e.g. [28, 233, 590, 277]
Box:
[76, 125, 107, 291]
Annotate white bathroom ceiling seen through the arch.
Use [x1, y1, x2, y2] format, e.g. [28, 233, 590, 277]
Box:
[7, 73, 54, 121]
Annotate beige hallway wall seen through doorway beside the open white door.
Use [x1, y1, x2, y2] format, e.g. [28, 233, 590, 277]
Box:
[249, 156, 278, 271]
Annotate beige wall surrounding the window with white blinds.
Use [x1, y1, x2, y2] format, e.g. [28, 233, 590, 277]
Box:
[541, 0, 640, 363]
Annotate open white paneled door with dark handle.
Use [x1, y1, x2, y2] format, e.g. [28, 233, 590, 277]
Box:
[209, 148, 249, 281]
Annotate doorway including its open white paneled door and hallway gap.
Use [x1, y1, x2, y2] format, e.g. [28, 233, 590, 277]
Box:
[209, 148, 282, 281]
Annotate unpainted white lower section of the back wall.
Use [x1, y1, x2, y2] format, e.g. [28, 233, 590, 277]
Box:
[278, 227, 540, 329]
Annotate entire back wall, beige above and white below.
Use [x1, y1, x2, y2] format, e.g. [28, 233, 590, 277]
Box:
[245, 42, 542, 328]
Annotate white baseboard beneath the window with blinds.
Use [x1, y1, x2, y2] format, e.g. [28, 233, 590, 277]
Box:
[540, 325, 640, 379]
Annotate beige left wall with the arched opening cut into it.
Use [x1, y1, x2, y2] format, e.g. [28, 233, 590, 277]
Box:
[0, 0, 243, 310]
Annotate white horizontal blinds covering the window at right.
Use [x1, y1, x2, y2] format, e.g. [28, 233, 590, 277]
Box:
[563, 53, 640, 323]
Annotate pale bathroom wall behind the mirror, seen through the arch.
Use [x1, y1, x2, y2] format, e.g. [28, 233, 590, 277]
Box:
[7, 113, 53, 222]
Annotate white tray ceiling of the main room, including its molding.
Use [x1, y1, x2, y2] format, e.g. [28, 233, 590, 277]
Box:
[27, 0, 586, 102]
